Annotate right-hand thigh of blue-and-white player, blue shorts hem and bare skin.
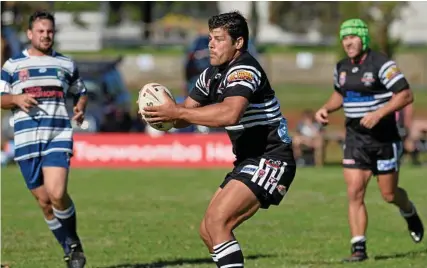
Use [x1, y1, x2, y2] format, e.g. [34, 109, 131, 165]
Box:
[42, 152, 70, 200]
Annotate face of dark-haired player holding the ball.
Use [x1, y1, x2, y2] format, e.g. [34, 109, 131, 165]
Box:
[209, 28, 243, 66]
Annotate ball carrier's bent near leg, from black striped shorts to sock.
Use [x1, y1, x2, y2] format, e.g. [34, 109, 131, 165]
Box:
[204, 158, 296, 267]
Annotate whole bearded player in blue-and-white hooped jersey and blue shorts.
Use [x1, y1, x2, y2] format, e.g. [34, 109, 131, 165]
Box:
[0, 12, 87, 268]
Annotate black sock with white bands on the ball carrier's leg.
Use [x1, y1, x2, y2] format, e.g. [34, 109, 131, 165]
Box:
[214, 240, 244, 268]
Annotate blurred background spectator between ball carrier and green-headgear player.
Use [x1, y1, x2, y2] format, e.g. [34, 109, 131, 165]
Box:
[292, 110, 324, 166]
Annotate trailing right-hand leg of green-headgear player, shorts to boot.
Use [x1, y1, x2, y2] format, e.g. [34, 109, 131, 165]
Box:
[377, 143, 424, 243]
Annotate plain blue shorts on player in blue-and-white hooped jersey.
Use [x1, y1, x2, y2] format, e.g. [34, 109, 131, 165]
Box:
[18, 152, 71, 190]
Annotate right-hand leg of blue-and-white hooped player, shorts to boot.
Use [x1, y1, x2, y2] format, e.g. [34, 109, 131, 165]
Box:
[42, 152, 86, 267]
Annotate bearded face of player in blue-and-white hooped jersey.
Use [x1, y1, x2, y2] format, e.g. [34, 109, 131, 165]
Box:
[27, 19, 55, 53]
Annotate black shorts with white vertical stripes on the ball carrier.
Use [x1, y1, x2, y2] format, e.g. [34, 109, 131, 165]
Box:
[220, 157, 296, 209]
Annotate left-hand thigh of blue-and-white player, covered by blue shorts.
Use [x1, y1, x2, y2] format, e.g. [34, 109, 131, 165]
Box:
[18, 157, 44, 191]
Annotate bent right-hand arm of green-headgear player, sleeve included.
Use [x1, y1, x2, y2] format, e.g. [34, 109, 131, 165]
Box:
[377, 60, 414, 117]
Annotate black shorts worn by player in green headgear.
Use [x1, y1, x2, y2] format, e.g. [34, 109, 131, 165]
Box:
[342, 142, 402, 175]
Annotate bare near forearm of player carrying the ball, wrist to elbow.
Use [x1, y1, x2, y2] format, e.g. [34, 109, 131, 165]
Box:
[179, 103, 239, 127]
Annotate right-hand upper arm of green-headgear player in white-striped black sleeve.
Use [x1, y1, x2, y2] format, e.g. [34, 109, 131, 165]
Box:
[378, 60, 409, 92]
